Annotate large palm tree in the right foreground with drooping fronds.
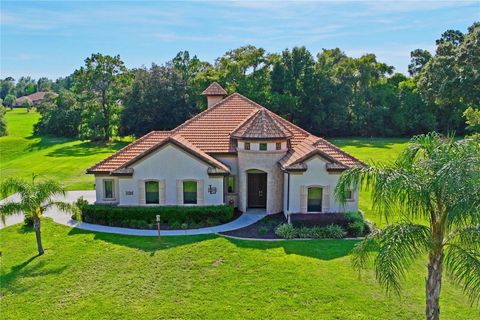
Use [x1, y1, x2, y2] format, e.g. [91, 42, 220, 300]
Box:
[335, 133, 480, 320]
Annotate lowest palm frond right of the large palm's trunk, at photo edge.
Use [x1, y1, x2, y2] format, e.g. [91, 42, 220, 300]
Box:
[444, 244, 480, 304]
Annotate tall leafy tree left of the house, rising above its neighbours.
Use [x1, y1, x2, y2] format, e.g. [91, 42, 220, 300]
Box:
[74, 53, 131, 140]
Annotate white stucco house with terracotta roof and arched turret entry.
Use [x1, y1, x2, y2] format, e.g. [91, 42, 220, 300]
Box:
[87, 82, 362, 214]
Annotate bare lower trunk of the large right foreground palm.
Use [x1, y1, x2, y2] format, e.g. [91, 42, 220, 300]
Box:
[426, 253, 443, 320]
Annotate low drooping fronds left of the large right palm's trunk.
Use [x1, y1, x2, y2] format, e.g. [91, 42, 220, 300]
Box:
[352, 223, 431, 293]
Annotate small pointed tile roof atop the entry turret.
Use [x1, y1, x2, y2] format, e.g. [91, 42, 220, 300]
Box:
[231, 108, 292, 139]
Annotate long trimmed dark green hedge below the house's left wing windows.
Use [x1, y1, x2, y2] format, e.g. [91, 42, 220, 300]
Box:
[79, 203, 233, 228]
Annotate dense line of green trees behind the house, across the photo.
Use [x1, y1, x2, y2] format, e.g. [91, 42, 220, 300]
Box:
[0, 23, 480, 140]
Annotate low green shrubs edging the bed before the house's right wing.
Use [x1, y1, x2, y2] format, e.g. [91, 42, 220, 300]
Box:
[275, 223, 347, 239]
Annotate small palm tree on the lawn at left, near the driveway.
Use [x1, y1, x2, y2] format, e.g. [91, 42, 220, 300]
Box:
[0, 175, 79, 255]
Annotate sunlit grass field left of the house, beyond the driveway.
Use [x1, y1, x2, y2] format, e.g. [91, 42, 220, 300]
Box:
[0, 109, 126, 190]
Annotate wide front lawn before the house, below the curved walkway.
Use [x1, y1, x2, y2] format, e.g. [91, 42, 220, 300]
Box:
[0, 220, 478, 320]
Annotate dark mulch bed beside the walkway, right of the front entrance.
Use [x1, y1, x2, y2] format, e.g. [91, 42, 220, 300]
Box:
[220, 213, 286, 239]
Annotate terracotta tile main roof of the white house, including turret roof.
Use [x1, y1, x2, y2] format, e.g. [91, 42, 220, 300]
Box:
[87, 85, 362, 174]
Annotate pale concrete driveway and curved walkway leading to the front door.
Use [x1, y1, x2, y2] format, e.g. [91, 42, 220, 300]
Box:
[0, 190, 265, 237]
